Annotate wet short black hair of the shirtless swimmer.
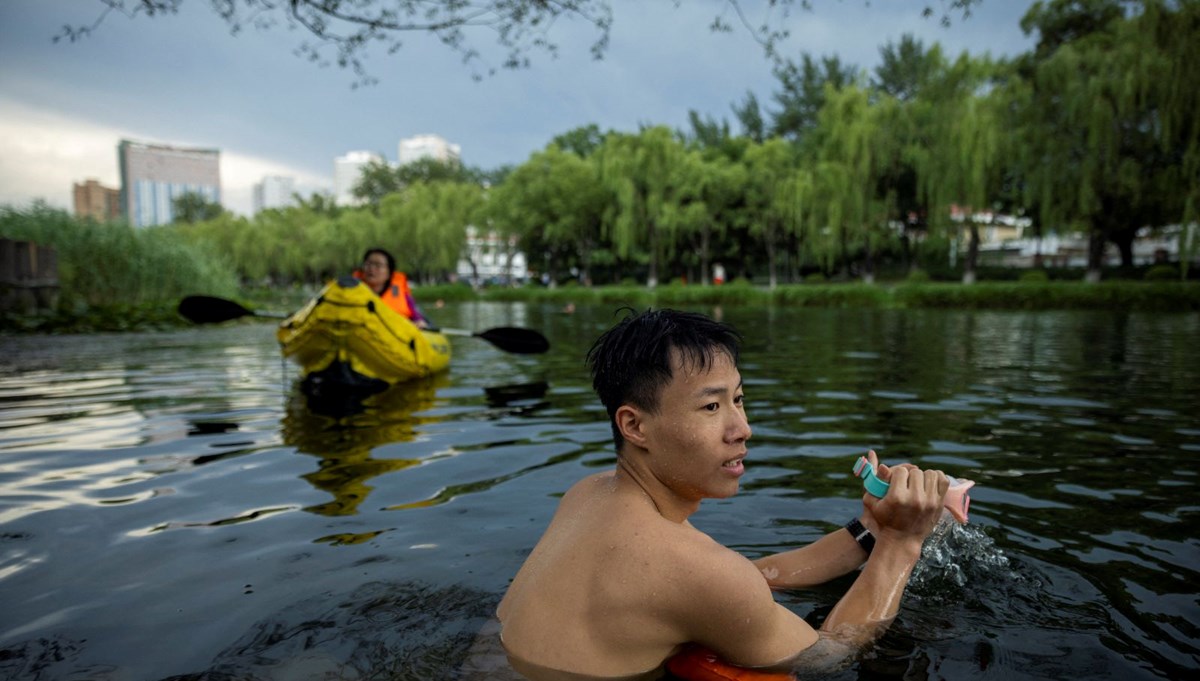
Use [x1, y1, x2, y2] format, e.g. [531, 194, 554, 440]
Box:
[587, 308, 742, 452]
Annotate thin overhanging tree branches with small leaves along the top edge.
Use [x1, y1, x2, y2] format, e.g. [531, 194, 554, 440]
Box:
[54, 0, 980, 85]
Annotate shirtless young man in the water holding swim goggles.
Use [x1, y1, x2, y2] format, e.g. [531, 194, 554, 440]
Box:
[497, 309, 948, 681]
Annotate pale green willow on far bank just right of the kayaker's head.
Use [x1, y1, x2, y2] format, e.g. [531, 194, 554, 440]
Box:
[378, 182, 485, 283]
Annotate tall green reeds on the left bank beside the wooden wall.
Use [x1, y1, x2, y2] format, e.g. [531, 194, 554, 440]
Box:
[0, 204, 238, 309]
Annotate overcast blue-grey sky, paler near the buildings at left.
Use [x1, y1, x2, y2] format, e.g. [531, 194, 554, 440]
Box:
[0, 0, 1032, 215]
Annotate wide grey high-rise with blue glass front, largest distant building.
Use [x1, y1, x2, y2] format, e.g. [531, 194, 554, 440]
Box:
[116, 139, 221, 227]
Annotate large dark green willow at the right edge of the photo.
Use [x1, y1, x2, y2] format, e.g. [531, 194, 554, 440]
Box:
[1014, 0, 1200, 281]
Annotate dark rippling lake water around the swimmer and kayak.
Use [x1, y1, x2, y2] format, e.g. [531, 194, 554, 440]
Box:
[0, 303, 1200, 680]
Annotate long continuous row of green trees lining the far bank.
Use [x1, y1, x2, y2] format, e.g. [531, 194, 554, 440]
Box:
[56, 0, 1200, 285]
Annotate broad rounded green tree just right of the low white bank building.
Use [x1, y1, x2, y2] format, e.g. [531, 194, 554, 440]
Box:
[487, 144, 607, 285]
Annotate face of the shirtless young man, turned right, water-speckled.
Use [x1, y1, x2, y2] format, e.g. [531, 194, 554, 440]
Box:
[643, 351, 750, 501]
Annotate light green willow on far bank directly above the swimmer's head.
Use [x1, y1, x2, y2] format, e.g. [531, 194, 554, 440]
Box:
[594, 126, 684, 288]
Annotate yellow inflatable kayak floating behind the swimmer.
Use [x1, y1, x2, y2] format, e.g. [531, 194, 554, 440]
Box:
[276, 277, 450, 391]
